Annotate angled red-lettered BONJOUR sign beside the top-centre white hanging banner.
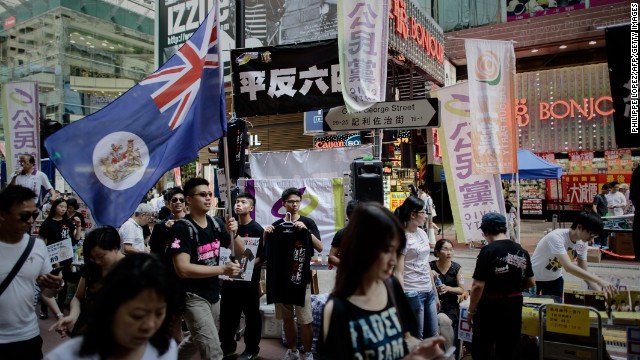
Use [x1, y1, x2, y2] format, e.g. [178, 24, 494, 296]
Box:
[389, 0, 445, 84]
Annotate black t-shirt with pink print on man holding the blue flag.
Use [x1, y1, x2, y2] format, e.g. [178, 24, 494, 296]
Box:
[167, 215, 231, 303]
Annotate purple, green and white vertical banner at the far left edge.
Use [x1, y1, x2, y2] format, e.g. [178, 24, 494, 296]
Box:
[2, 81, 40, 179]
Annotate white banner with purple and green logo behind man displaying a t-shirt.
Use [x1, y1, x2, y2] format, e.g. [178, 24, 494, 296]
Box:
[239, 178, 344, 255]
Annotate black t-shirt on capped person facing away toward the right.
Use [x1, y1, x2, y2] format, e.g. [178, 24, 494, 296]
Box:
[473, 240, 533, 296]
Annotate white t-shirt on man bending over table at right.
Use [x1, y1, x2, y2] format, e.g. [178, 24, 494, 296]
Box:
[531, 229, 588, 281]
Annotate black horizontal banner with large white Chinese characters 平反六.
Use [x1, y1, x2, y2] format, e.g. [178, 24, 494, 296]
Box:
[231, 40, 344, 117]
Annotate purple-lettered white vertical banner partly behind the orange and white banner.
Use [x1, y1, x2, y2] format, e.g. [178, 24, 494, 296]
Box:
[436, 83, 505, 243]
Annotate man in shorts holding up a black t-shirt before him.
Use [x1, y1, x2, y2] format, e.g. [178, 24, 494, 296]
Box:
[264, 187, 322, 360]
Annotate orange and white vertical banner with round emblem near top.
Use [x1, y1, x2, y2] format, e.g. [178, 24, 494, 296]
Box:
[464, 40, 518, 174]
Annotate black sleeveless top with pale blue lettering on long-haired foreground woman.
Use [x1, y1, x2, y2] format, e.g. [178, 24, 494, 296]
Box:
[318, 277, 417, 360]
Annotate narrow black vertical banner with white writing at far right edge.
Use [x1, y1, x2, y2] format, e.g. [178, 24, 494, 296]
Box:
[604, 25, 640, 148]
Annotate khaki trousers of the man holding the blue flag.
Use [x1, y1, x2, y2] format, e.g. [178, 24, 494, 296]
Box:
[178, 292, 222, 360]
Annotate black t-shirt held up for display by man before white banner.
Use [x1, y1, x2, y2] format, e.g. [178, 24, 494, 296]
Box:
[266, 216, 320, 306]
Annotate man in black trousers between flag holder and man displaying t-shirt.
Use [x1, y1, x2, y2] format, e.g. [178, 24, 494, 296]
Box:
[220, 193, 265, 360]
